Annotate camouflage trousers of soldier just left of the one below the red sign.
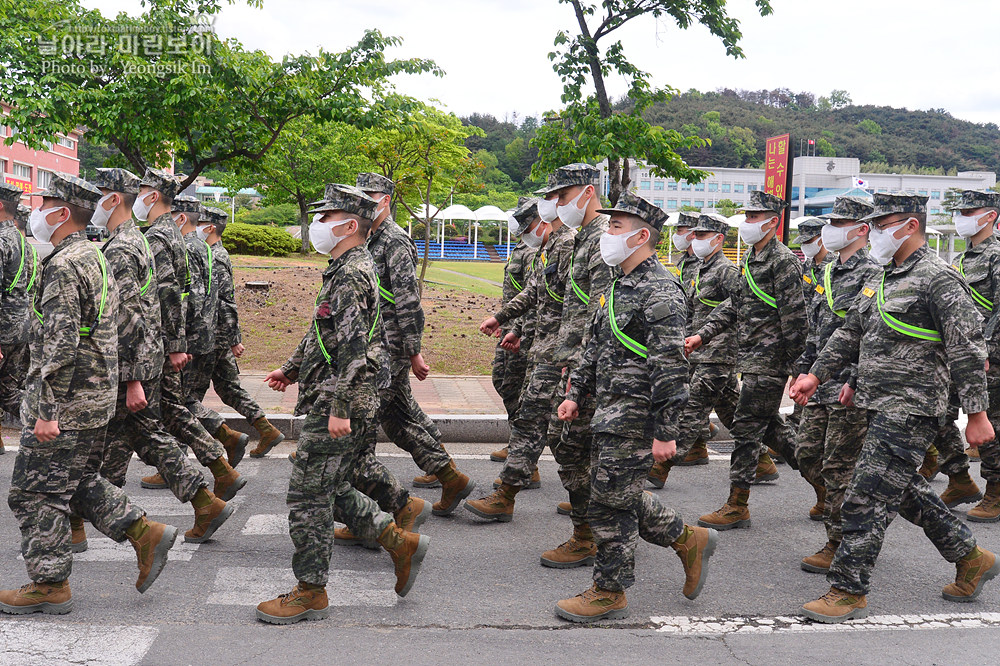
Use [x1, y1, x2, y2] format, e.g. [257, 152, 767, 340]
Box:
[673, 363, 740, 460]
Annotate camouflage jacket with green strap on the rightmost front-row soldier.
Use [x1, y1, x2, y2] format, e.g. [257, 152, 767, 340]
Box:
[811, 243, 989, 416]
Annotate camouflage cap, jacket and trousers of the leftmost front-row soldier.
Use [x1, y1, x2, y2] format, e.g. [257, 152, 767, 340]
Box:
[7, 173, 144, 582]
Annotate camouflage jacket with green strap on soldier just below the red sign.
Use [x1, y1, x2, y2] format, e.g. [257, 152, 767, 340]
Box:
[697, 238, 809, 377]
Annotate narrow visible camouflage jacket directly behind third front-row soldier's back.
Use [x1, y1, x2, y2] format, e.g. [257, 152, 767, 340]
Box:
[555, 215, 611, 368]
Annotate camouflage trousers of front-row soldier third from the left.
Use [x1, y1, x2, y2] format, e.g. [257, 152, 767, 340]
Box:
[590, 433, 684, 592]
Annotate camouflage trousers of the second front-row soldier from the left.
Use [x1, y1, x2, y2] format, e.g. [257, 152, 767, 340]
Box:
[285, 406, 393, 585]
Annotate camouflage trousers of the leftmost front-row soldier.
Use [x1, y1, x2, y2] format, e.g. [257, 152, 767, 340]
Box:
[7, 423, 145, 582]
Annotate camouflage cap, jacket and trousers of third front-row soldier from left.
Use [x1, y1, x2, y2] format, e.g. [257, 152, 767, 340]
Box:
[566, 192, 688, 592]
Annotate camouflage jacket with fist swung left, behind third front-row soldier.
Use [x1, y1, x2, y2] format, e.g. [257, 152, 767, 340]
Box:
[495, 224, 575, 363]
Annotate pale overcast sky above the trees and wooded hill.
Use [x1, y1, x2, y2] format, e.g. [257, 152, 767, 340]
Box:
[84, 0, 1000, 123]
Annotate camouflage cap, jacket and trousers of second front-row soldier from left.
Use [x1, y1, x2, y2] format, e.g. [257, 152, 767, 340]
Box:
[281, 185, 392, 586]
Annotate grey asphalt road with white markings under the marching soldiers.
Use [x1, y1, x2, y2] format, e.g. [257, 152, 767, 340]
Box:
[0, 440, 1000, 666]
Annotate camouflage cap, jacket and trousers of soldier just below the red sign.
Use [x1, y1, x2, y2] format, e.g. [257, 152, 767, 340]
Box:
[697, 191, 809, 489]
